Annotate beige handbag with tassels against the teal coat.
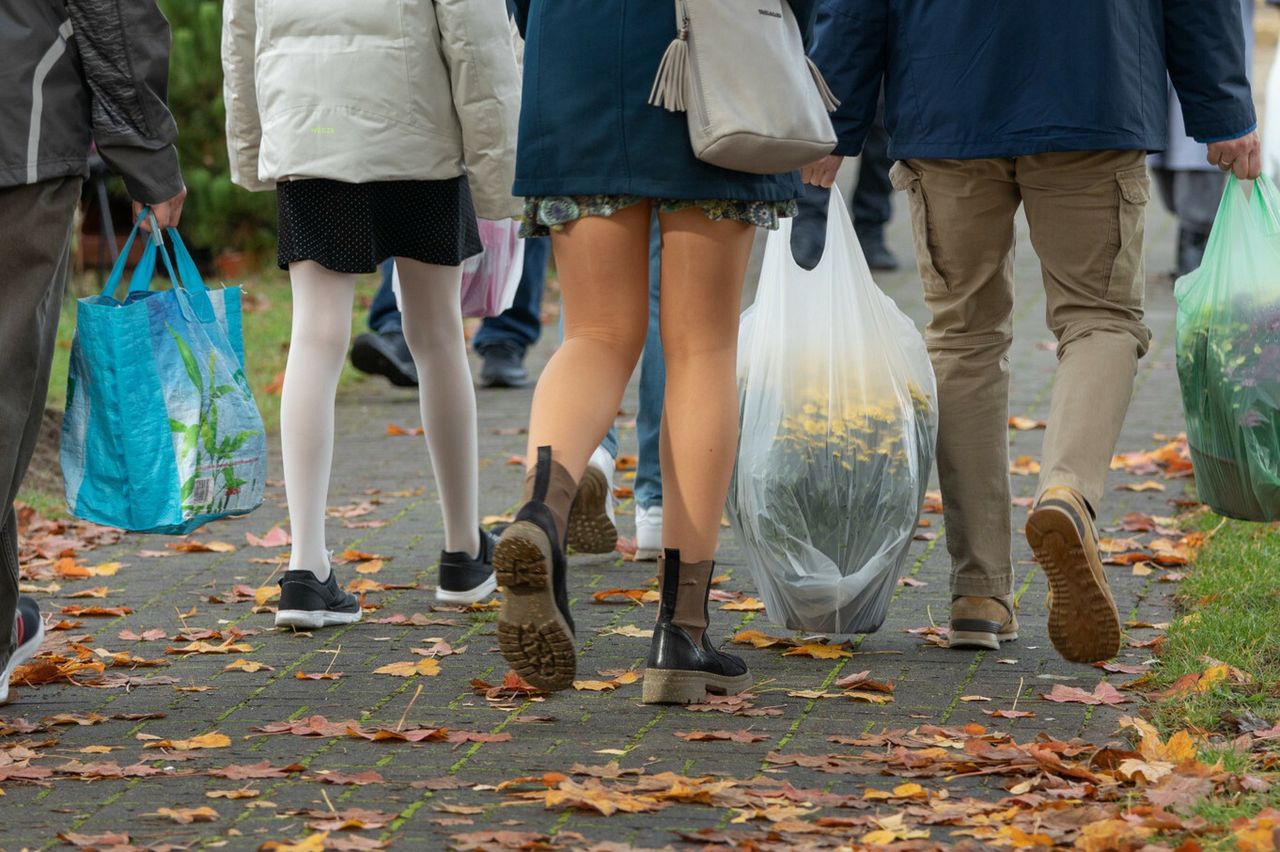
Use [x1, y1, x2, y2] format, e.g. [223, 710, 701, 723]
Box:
[649, 0, 840, 174]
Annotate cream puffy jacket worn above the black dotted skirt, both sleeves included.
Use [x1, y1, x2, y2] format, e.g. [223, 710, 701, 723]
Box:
[223, 0, 520, 219]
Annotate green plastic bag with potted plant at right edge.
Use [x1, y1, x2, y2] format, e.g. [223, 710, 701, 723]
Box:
[1175, 177, 1280, 521]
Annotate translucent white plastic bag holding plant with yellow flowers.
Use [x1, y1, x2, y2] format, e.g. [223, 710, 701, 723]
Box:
[728, 189, 938, 633]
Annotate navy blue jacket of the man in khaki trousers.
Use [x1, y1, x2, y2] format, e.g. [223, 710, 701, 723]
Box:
[809, 0, 1257, 160]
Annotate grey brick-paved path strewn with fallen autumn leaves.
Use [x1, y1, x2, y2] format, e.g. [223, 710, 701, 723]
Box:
[0, 203, 1185, 849]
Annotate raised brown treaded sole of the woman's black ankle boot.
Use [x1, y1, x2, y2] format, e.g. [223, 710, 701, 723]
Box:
[493, 521, 577, 691]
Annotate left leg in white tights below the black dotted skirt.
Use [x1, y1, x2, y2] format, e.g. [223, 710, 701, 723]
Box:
[280, 261, 356, 582]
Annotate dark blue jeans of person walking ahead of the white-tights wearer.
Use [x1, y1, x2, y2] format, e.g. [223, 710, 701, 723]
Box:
[369, 237, 550, 354]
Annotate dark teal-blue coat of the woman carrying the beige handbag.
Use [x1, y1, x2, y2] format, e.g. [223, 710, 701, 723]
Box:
[515, 0, 815, 201]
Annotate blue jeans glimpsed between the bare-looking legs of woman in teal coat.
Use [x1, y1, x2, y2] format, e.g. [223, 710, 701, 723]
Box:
[600, 215, 667, 509]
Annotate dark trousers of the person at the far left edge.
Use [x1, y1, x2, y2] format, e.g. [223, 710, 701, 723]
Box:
[0, 178, 81, 667]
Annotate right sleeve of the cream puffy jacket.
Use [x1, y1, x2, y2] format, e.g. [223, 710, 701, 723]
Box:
[435, 0, 520, 220]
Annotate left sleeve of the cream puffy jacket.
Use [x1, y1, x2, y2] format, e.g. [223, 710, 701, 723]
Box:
[223, 0, 275, 192]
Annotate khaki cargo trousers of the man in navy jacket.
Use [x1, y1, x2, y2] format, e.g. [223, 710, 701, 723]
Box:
[891, 151, 1151, 596]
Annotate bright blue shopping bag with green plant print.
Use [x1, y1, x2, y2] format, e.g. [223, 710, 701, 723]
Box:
[61, 211, 266, 535]
